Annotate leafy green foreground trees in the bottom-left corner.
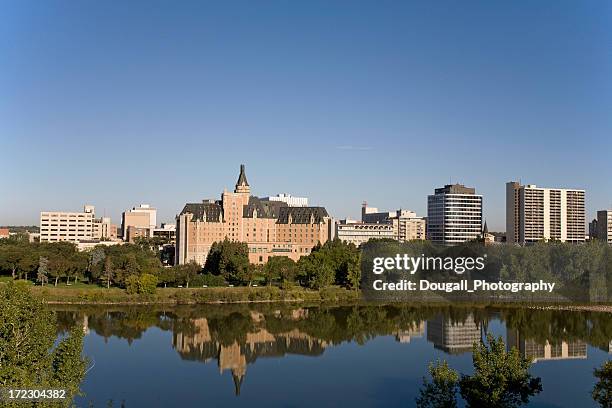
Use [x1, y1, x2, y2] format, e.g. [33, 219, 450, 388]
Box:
[0, 282, 87, 407]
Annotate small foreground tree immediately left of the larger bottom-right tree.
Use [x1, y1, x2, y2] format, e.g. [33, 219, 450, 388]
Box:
[416, 361, 459, 408]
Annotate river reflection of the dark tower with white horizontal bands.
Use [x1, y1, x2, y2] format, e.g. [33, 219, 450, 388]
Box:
[427, 315, 480, 354]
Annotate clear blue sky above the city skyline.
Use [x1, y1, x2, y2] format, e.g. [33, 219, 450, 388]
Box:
[0, 0, 612, 230]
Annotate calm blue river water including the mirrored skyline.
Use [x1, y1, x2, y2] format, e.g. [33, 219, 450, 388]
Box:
[57, 304, 612, 407]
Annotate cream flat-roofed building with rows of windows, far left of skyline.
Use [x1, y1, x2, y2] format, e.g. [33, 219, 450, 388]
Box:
[40, 205, 95, 243]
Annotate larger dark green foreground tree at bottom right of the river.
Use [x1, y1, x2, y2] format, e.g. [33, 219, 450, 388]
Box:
[459, 334, 542, 408]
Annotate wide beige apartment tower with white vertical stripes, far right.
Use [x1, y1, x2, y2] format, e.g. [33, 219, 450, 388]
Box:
[506, 181, 586, 244]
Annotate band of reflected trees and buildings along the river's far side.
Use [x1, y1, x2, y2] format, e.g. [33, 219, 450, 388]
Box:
[58, 305, 612, 402]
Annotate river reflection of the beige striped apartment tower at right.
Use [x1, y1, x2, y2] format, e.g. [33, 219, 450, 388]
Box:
[506, 330, 587, 363]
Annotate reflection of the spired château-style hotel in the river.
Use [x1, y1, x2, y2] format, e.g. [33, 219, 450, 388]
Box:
[172, 309, 327, 395]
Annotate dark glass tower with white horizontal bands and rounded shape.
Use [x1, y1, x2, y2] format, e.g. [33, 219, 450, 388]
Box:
[427, 184, 482, 245]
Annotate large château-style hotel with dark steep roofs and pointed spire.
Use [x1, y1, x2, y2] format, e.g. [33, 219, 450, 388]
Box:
[175, 165, 333, 265]
